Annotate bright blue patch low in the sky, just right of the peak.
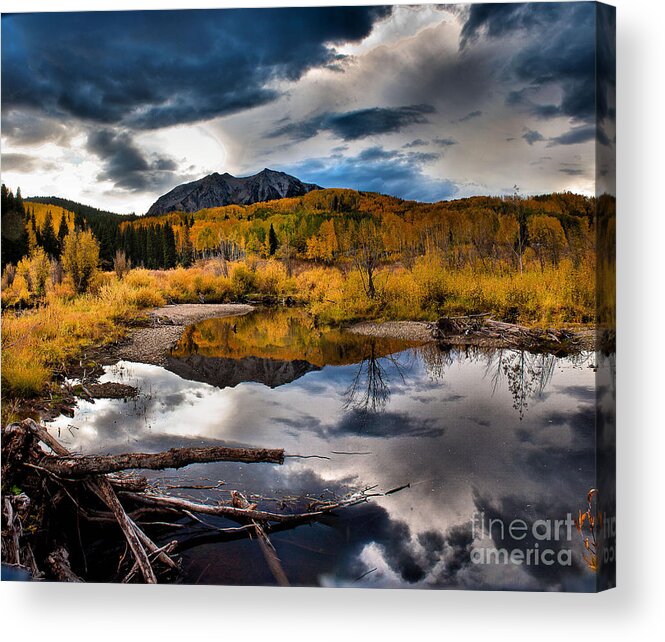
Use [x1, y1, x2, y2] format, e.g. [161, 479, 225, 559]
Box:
[284, 147, 458, 202]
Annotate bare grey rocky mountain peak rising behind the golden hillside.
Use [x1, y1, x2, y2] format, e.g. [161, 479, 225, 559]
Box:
[147, 168, 321, 216]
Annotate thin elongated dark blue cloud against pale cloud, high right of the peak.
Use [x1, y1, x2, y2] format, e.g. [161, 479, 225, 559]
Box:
[268, 105, 435, 141]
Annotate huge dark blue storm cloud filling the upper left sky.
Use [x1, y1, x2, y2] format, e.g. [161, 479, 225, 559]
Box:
[2, 7, 391, 128]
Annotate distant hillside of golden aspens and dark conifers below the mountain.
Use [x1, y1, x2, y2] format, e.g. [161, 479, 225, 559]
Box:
[3, 189, 595, 270]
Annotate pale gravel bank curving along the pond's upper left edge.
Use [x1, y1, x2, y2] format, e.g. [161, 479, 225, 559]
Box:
[114, 303, 253, 366]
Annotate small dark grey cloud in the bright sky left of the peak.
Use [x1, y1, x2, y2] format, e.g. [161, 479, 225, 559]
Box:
[87, 129, 182, 192]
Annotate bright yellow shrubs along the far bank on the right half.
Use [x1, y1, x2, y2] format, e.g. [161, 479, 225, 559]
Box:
[290, 257, 595, 325]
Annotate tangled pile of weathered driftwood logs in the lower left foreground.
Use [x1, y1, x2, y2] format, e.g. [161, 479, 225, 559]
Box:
[2, 419, 390, 585]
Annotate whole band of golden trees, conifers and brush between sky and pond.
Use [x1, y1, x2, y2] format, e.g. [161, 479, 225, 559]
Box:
[2, 181, 600, 395]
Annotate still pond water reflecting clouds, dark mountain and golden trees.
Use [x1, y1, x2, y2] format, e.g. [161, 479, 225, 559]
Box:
[51, 309, 595, 591]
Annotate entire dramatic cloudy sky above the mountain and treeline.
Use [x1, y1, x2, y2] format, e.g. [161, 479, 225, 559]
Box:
[2, 3, 614, 213]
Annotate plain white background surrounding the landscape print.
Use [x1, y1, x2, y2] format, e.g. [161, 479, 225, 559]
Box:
[0, 0, 665, 642]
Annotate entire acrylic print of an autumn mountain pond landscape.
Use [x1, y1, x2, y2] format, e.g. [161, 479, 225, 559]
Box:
[2, 2, 616, 592]
